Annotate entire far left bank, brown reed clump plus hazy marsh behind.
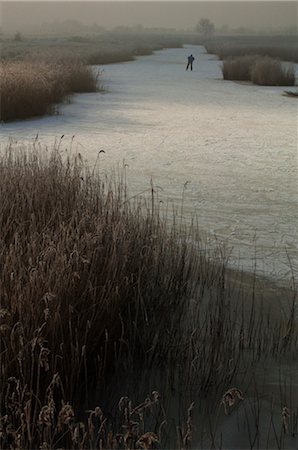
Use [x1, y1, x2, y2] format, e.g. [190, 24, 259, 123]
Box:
[0, 33, 198, 121]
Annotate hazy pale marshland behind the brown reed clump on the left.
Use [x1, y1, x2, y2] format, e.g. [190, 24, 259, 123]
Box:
[0, 32, 197, 64]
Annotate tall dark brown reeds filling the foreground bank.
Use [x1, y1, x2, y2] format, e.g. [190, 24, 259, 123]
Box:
[0, 142, 298, 449]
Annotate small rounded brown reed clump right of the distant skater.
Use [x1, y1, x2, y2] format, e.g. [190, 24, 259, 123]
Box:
[222, 55, 296, 86]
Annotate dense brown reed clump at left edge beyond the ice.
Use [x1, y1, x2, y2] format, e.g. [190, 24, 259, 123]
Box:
[0, 58, 98, 121]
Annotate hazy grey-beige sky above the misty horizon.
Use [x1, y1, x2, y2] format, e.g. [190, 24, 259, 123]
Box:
[1, 0, 297, 31]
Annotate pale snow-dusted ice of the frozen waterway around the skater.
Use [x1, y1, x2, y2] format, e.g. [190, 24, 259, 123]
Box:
[0, 46, 298, 279]
